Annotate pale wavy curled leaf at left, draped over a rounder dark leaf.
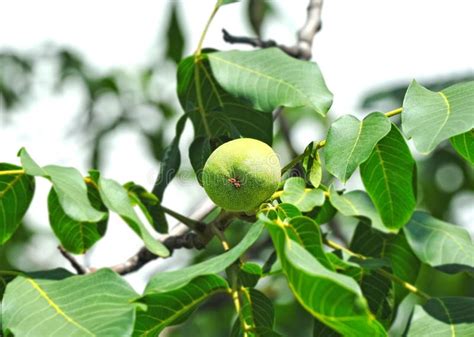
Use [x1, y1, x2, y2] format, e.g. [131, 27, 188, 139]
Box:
[19, 149, 107, 222]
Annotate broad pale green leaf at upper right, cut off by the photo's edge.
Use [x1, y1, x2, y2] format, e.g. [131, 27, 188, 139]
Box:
[402, 81, 474, 153]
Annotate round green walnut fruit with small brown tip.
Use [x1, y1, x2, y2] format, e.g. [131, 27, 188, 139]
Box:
[202, 138, 281, 212]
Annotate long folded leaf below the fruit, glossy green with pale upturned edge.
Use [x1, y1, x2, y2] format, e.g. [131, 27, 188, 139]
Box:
[266, 220, 387, 337]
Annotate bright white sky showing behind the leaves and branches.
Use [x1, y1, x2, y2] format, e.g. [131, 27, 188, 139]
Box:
[0, 0, 474, 286]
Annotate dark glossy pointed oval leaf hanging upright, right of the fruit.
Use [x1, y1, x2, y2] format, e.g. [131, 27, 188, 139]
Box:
[360, 124, 416, 230]
